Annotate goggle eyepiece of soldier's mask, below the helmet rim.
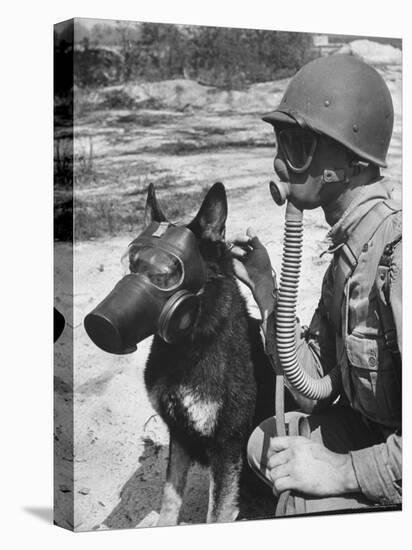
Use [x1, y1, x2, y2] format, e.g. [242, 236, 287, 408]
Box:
[277, 128, 317, 174]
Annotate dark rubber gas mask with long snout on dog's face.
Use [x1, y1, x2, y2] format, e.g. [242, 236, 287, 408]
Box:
[84, 221, 206, 354]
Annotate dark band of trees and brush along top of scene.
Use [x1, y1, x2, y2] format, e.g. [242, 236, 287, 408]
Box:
[54, 22, 312, 89]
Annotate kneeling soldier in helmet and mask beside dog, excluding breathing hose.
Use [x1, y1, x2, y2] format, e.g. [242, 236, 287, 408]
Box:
[232, 55, 402, 514]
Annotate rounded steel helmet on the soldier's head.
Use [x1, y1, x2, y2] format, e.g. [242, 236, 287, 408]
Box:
[263, 54, 393, 167]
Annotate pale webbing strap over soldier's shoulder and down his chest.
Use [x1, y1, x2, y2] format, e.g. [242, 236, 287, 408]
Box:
[330, 199, 401, 334]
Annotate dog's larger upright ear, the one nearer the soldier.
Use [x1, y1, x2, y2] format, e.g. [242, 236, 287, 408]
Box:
[188, 182, 227, 241]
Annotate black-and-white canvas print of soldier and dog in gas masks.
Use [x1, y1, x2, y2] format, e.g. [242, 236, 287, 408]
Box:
[54, 18, 402, 531]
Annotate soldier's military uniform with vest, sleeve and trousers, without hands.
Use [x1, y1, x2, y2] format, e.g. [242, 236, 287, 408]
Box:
[248, 179, 402, 514]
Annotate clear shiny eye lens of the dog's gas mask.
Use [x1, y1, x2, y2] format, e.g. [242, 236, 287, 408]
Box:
[128, 246, 183, 290]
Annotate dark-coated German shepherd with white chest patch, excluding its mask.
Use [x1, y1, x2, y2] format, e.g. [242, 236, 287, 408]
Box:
[141, 183, 274, 525]
